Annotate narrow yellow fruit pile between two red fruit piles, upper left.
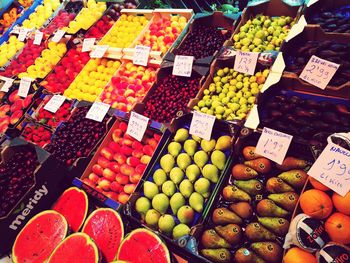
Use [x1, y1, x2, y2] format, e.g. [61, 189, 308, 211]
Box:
[18, 42, 67, 79]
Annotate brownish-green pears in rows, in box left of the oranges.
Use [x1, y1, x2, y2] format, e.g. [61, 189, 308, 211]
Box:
[200, 146, 308, 263]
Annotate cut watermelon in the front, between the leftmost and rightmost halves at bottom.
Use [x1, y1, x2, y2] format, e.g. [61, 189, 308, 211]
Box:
[47, 233, 100, 263]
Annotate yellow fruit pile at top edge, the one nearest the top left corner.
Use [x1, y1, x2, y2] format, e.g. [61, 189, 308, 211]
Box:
[22, 0, 61, 29]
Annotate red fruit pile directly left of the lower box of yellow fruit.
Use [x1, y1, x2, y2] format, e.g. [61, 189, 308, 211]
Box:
[41, 47, 90, 93]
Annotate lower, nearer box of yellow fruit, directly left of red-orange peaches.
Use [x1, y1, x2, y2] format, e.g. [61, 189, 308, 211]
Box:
[64, 58, 121, 102]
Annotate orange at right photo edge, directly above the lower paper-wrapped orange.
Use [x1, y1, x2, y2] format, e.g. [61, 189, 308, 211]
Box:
[325, 212, 350, 245]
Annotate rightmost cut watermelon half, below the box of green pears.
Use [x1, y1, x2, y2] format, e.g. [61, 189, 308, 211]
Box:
[117, 228, 170, 263]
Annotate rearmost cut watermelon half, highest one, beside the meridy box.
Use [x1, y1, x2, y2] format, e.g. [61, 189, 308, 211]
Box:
[52, 187, 89, 232]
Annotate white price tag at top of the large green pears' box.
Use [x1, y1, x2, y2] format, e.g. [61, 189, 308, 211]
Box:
[190, 111, 215, 141]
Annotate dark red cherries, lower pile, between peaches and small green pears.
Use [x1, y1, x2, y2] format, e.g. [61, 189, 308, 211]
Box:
[143, 75, 200, 123]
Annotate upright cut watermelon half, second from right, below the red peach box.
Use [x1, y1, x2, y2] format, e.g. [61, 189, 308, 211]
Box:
[82, 208, 124, 262]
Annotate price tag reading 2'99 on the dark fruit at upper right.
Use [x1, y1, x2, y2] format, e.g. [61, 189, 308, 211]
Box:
[299, 56, 339, 89]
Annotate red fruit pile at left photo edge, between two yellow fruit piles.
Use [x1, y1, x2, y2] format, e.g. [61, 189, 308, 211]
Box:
[0, 39, 46, 77]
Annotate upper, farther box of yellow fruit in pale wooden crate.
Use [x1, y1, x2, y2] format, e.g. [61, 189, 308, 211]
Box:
[100, 14, 148, 48]
